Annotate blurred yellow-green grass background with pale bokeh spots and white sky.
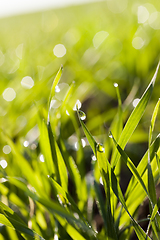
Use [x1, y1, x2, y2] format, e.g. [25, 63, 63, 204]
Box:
[0, 0, 160, 169]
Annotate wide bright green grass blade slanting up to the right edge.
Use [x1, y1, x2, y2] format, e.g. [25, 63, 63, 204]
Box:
[111, 63, 160, 168]
